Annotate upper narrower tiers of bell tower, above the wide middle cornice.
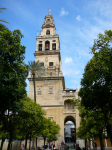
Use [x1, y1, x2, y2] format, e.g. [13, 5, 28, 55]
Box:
[34, 12, 63, 77]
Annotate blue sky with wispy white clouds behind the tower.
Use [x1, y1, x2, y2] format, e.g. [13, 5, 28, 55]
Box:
[0, 0, 112, 91]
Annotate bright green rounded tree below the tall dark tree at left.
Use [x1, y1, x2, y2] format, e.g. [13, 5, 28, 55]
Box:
[0, 96, 45, 149]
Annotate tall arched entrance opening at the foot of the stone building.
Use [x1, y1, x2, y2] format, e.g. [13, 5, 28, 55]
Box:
[64, 116, 76, 143]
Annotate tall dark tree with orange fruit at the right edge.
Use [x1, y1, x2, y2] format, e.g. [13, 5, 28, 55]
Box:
[79, 30, 112, 143]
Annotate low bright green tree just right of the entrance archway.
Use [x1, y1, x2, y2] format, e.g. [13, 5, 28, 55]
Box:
[71, 99, 106, 150]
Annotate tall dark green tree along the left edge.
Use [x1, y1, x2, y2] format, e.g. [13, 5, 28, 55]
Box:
[0, 24, 28, 149]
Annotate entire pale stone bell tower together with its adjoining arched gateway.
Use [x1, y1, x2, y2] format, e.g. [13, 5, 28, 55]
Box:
[29, 13, 84, 146]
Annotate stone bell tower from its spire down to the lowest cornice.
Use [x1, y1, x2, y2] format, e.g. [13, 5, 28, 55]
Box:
[29, 12, 65, 107]
